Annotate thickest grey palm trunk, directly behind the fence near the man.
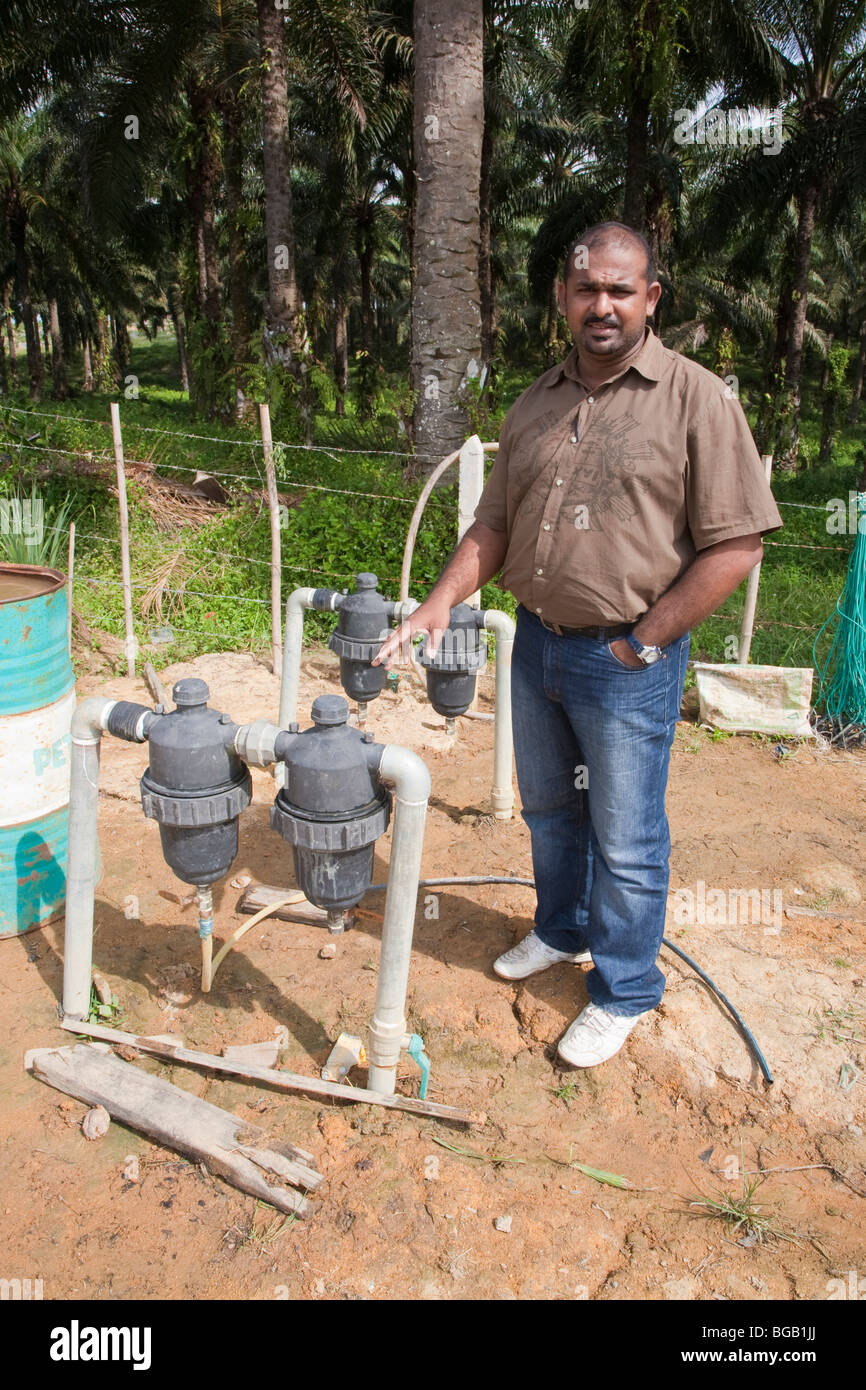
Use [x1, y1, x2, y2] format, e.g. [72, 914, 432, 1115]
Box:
[411, 0, 484, 471]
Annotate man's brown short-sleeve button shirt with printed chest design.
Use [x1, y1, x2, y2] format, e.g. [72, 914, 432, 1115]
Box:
[475, 329, 781, 627]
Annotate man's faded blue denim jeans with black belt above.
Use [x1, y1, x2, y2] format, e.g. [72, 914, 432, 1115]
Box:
[512, 606, 689, 1016]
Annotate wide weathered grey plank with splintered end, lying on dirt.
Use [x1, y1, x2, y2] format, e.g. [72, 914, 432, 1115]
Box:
[25, 1043, 322, 1216]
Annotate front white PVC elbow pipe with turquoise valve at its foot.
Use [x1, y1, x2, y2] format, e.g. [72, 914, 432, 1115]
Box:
[367, 744, 430, 1095]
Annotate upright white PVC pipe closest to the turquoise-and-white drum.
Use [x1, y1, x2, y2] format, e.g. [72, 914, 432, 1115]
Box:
[63, 696, 117, 1019]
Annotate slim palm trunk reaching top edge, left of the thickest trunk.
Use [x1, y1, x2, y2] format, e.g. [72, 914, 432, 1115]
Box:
[256, 0, 297, 350]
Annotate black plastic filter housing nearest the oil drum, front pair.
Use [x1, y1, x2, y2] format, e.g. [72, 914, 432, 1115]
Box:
[142, 678, 252, 885]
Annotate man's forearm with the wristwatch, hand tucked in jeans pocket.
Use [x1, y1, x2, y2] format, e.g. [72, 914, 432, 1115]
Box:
[634, 534, 763, 646]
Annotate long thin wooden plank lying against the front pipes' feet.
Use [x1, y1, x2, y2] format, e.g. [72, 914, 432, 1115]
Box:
[60, 1019, 487, 1125]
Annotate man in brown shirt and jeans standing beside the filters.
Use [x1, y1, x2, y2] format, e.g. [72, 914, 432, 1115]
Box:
[377, 222, 781, 1066]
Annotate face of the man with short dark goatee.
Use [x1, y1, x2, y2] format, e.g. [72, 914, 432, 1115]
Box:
[556, 242, 662, 363]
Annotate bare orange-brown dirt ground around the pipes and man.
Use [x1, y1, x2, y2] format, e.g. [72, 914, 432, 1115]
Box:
[0, 651, 866, 1300]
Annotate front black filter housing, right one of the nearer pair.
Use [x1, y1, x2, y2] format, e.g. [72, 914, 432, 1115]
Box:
[271, 695, 391, 912]
